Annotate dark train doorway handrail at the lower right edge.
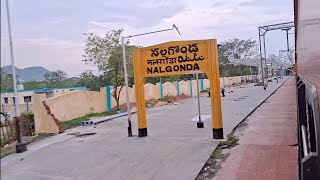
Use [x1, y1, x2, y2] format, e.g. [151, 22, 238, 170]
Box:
[297, 76, 320, 180]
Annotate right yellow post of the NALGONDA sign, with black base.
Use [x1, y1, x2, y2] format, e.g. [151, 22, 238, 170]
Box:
[207, 40, 223, 139]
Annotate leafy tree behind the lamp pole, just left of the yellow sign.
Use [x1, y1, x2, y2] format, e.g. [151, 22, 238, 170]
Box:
[83, 29, 134, 109]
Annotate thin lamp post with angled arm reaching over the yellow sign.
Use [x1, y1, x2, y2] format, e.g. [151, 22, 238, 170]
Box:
[121, 24, 181, 137]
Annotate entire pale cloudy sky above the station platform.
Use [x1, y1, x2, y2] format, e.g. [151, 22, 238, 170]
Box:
[1, 0, 293, 77]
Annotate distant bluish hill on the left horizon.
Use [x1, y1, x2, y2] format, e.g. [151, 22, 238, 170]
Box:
[1, 65, 50, 81]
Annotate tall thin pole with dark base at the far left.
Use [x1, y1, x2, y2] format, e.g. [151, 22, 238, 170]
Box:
[6, 0, 27, 153]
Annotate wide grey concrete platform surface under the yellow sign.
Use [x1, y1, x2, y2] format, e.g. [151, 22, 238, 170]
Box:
[1, 80, 284, 180]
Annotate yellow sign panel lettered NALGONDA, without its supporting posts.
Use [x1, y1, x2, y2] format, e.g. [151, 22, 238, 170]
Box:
[140, 41, 209, 77]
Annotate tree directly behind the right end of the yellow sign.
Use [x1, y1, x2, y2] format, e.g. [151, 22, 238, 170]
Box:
[219, 38, 258, 76]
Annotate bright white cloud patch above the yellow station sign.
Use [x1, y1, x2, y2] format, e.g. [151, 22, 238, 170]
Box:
[89, 0, 293, 46]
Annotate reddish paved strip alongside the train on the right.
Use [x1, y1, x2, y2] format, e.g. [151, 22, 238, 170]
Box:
[214, 77, 297, 180]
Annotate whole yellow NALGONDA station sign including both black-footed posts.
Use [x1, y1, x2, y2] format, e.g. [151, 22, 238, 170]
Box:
[134, 39, 223, 139]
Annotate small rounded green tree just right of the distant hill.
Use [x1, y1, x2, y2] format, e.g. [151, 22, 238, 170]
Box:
[44, 70, 67, 88]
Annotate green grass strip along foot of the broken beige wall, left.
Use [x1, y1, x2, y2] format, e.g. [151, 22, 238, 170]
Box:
[61, 112, 116, 129]
